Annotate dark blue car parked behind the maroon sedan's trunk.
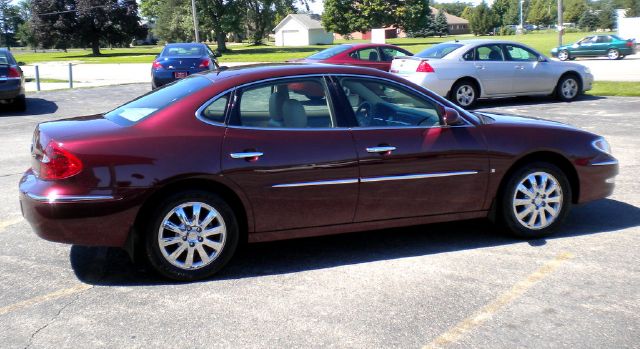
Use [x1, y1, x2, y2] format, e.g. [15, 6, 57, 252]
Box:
[151, 43, 220, 88]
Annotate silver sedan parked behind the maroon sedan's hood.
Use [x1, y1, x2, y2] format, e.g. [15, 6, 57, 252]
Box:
[391, 40, 593, 108]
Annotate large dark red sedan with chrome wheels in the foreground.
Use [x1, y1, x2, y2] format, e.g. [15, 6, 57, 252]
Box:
[20, 64, 618, 280]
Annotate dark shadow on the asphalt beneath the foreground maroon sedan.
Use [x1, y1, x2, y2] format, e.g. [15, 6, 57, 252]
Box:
[71, 199, 640, 286]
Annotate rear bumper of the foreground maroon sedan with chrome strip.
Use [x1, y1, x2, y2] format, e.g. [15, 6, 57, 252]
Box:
[20, 170, 139, 247]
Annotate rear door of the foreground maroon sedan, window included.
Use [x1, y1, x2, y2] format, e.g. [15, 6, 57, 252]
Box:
[221, 77, 358, 232]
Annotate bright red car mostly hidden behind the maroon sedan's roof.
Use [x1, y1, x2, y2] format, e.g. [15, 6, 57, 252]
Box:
[290, 44, 412, 71]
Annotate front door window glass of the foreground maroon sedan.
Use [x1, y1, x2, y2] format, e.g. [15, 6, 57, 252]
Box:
[340, 78, 440, 127]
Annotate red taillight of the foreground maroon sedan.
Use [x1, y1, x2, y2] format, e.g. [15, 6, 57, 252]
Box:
[37, 141, 82, 180]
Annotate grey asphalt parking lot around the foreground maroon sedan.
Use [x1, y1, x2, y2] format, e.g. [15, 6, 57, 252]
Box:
[0, 84, 640, 348]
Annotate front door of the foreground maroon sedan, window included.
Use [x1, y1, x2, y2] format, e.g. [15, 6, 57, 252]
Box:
[332, 77, 488, 222]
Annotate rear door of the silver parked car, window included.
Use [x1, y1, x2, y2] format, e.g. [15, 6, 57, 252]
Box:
[473, 44, 516, 96]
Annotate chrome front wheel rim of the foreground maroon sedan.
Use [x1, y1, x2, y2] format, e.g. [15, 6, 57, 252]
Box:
[512, 172, 563, 230]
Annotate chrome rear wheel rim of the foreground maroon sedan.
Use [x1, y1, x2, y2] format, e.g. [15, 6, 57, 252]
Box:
[158, 202, 227, 270]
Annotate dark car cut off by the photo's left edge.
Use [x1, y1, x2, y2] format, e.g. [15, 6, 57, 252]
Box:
[0, 48, 27, 111]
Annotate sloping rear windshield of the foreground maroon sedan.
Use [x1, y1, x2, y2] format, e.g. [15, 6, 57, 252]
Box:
[104, 76, 211, 125]
